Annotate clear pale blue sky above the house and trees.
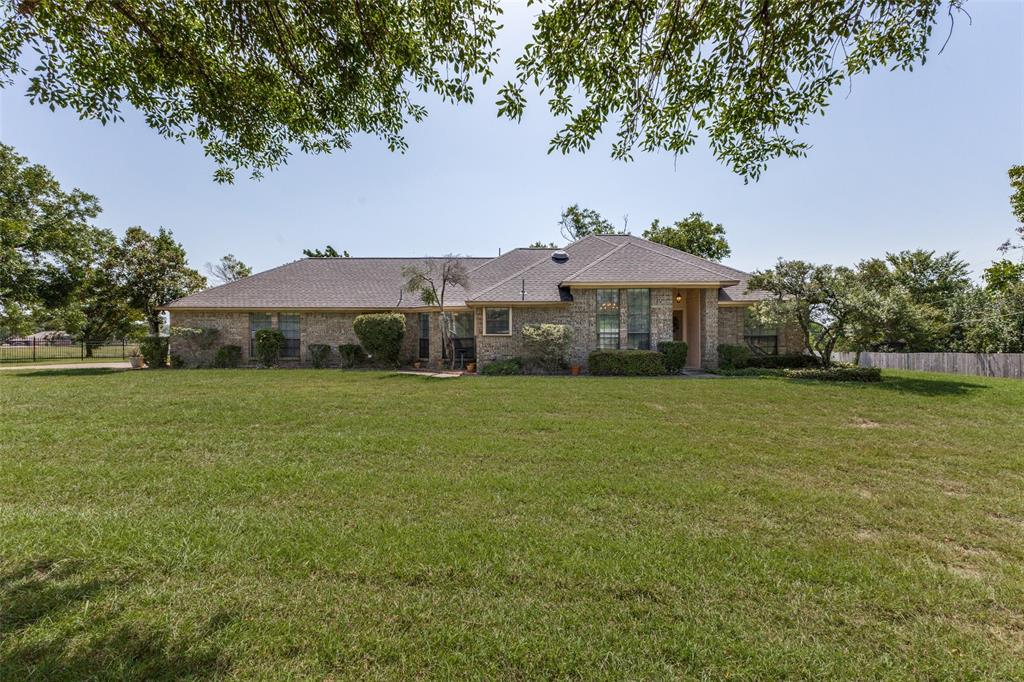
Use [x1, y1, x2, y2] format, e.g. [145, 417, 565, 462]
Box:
[0, 0, 1024, 273]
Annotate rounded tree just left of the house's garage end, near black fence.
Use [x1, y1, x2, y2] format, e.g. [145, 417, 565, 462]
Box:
[112, 227, 206, 336]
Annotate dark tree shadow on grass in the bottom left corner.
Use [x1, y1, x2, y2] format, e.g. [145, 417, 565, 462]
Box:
[0, 561, 231, 680]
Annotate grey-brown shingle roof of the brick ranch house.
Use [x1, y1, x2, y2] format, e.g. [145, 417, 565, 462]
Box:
[166, 235, 766, 310]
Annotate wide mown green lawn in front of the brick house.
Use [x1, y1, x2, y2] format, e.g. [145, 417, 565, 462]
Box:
[0, 370, 1024, 680]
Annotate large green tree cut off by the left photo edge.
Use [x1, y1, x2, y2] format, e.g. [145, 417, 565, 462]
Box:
[0, 144, 112, 330]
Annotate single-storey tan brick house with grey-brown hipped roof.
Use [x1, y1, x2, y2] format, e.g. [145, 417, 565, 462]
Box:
[166, 235, 802, 368]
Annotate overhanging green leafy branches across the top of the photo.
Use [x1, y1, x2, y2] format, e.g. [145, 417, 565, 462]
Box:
[0, 0, 966, 180]
